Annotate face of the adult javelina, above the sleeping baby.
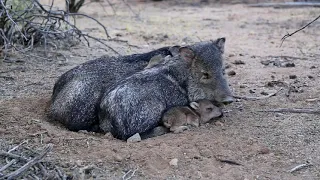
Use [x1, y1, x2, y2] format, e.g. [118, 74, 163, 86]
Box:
[188, 38, 234, 104]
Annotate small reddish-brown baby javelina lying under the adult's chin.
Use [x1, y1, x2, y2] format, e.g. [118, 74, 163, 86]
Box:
[162, 99, 222, 133]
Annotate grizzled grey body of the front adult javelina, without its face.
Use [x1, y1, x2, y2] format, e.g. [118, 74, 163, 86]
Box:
[99, 48, 194, 140]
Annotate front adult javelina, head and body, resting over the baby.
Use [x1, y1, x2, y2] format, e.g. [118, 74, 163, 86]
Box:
[99, 38, 233, 139]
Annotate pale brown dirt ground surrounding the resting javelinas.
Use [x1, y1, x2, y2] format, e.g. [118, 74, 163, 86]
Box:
[0, 2, 320, 180]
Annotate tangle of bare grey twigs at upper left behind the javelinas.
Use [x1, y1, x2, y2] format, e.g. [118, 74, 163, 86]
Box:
[0, 0, 119, 58]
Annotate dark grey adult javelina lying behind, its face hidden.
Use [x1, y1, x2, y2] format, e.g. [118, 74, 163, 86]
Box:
[49, 47, 172, 131]
